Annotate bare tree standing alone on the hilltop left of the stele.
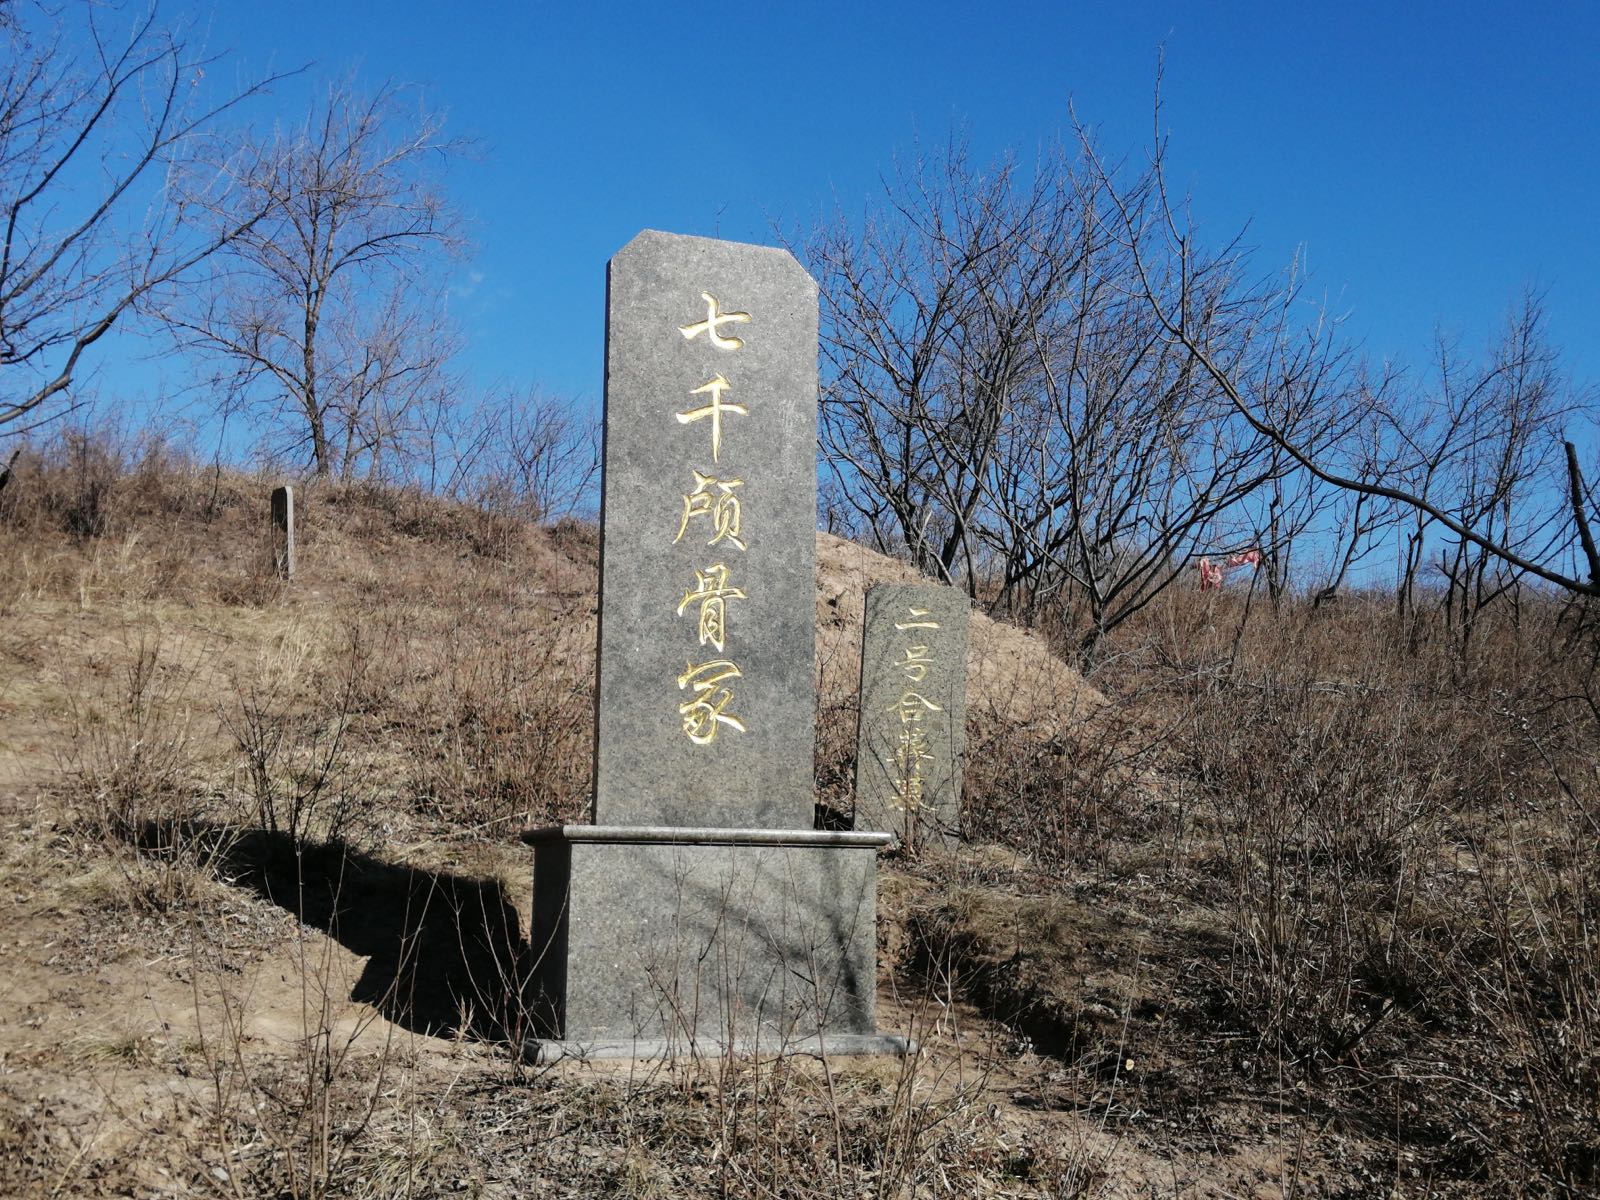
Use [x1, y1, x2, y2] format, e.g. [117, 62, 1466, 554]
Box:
[166, 72, 459, 475]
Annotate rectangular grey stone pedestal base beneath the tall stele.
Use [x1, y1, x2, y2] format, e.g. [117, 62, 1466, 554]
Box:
[523, 826, 906, 1059]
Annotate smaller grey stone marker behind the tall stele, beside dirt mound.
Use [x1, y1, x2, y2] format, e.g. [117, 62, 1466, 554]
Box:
[854, 584, 970, 848]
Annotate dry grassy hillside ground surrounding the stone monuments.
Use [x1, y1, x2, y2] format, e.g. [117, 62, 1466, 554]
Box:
[0, 443, 1600, 1197]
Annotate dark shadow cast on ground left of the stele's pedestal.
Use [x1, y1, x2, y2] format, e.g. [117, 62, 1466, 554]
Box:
[139, 827, 531, 1042]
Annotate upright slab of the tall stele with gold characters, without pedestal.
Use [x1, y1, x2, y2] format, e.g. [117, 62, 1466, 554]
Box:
[595, 234, 818, 829]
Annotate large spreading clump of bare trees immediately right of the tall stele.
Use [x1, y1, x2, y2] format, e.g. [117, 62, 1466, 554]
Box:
[806, 130, 1347, 656]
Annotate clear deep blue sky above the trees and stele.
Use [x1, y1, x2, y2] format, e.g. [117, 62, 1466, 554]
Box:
[140, 0, 1600, 412]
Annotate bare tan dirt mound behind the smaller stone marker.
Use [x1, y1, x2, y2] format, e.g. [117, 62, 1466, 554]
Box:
[816, 533, 1109, 733]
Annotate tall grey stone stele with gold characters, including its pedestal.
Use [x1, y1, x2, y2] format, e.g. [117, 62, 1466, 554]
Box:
[525, 232, 906, 1059]
